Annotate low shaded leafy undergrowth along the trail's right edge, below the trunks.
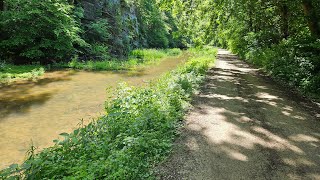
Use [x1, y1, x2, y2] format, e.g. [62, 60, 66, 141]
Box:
[245, 39, 320, 100]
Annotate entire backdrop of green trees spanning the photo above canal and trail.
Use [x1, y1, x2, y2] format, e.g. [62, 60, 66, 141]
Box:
[0, 0, 320, 93]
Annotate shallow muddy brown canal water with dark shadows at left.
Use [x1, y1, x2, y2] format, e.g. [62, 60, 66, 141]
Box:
[0, 55, 187, 169]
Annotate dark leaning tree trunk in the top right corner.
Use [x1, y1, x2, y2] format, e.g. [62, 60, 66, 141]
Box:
[302, 0, 320, 37]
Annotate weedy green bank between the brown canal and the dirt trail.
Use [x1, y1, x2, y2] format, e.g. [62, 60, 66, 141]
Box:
[0, 48, 217, 179]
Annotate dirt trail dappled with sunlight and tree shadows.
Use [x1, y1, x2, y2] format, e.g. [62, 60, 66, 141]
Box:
[158, 50, 320, 180]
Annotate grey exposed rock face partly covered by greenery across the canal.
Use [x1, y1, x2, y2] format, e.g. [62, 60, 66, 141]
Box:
[80, 0, 141, 56]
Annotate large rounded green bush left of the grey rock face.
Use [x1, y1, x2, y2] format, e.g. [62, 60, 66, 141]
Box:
[0, 0, 85, 64]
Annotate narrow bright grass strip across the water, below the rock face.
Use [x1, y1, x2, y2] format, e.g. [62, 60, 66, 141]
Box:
[54, 49, 182, 71]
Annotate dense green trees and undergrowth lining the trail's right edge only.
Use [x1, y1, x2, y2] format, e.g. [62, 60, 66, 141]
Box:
[216, 0, 320, 96]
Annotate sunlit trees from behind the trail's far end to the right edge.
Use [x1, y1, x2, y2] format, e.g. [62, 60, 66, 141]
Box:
[160, 0, 320, 97]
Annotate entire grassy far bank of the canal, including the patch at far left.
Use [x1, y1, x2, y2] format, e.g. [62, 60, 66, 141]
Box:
[0, 49, 182, 83]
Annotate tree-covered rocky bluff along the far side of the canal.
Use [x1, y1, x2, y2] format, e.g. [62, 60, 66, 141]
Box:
[0, 0, 182, 64]
